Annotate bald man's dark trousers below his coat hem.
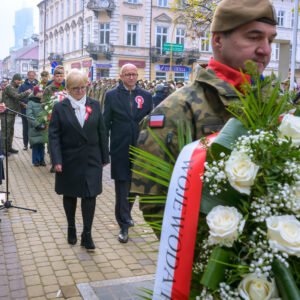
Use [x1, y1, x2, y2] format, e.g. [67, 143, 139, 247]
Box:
[115, 180, 133, 228]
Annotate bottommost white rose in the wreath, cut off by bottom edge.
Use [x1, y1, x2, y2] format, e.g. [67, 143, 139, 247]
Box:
[238, 274, 277, 300]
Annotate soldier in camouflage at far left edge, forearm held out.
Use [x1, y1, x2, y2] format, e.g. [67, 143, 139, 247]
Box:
[1, 74, 32, 155]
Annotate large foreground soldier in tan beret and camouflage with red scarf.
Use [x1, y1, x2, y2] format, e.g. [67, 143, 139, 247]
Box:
[130, 0, 276, 237]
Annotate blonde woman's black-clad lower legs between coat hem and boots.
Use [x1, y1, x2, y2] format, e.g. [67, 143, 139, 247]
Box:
[63, 196, 96, 232]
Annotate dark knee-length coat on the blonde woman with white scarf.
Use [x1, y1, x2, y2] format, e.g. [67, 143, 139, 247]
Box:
[49, 98, 109, 197]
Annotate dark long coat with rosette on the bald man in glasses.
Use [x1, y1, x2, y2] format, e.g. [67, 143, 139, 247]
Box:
[103, 83, 152, 181]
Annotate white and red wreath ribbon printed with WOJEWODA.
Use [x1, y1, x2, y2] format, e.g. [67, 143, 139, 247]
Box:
[153, 134, 217, 300]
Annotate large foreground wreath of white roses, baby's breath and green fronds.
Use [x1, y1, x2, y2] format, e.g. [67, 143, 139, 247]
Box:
[131, 62, 300, 300]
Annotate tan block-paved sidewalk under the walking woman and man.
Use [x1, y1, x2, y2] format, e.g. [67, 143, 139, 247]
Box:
[0, 117, 158, 300]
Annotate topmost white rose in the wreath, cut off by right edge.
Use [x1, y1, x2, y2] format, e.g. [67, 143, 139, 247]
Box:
[278, 114, 300, 146]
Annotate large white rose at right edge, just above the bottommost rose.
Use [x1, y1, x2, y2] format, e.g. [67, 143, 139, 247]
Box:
[266, 215, 300, 257]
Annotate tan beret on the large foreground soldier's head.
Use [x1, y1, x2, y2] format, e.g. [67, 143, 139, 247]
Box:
[211, 0, 277, 32]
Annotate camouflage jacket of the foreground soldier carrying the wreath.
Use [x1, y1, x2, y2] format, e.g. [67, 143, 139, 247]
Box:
[131, 68, 239, 195]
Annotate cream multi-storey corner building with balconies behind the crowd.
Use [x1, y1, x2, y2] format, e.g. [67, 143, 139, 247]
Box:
[38, 0, 300, 81]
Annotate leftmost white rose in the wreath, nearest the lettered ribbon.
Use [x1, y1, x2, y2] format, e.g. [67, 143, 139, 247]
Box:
[206, 205, 245, 247]
